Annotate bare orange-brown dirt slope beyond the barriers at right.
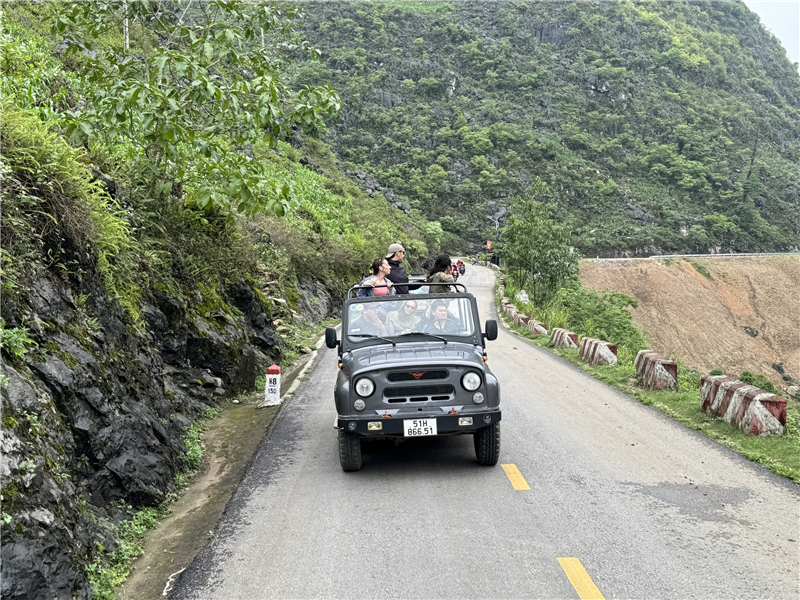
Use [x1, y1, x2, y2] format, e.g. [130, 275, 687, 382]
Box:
[580, 255, 800, 388]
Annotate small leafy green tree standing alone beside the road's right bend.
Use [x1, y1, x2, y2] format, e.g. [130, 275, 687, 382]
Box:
[498, 177, 578, 305]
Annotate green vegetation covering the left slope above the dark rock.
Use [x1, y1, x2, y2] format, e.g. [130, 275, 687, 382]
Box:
[2, 3, 438, 338]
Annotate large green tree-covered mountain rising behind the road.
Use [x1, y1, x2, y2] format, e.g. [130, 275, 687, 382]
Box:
[294, 1, 800, 254]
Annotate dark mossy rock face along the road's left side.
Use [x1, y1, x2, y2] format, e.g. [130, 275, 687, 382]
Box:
[0, 260, 310, 599]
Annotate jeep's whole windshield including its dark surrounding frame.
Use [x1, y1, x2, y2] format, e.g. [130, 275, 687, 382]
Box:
[339, 284, 485, 353]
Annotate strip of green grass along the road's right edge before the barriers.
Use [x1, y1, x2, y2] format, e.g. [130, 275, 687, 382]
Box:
[496, 284, 800, 483]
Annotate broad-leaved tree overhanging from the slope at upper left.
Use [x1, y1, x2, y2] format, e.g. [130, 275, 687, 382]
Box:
[52, 0, 340, 214]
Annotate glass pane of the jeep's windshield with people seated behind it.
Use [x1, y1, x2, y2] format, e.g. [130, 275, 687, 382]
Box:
[342, 295, 475, 342]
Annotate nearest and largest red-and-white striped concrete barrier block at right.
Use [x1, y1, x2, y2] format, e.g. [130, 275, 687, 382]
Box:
[700, 375, 786, 435]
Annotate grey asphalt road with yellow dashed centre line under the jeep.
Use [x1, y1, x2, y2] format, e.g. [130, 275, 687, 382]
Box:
[171, 266, 800, 599]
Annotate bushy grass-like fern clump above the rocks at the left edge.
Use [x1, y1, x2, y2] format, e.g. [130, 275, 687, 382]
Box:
[0, 100, 142, 323]
